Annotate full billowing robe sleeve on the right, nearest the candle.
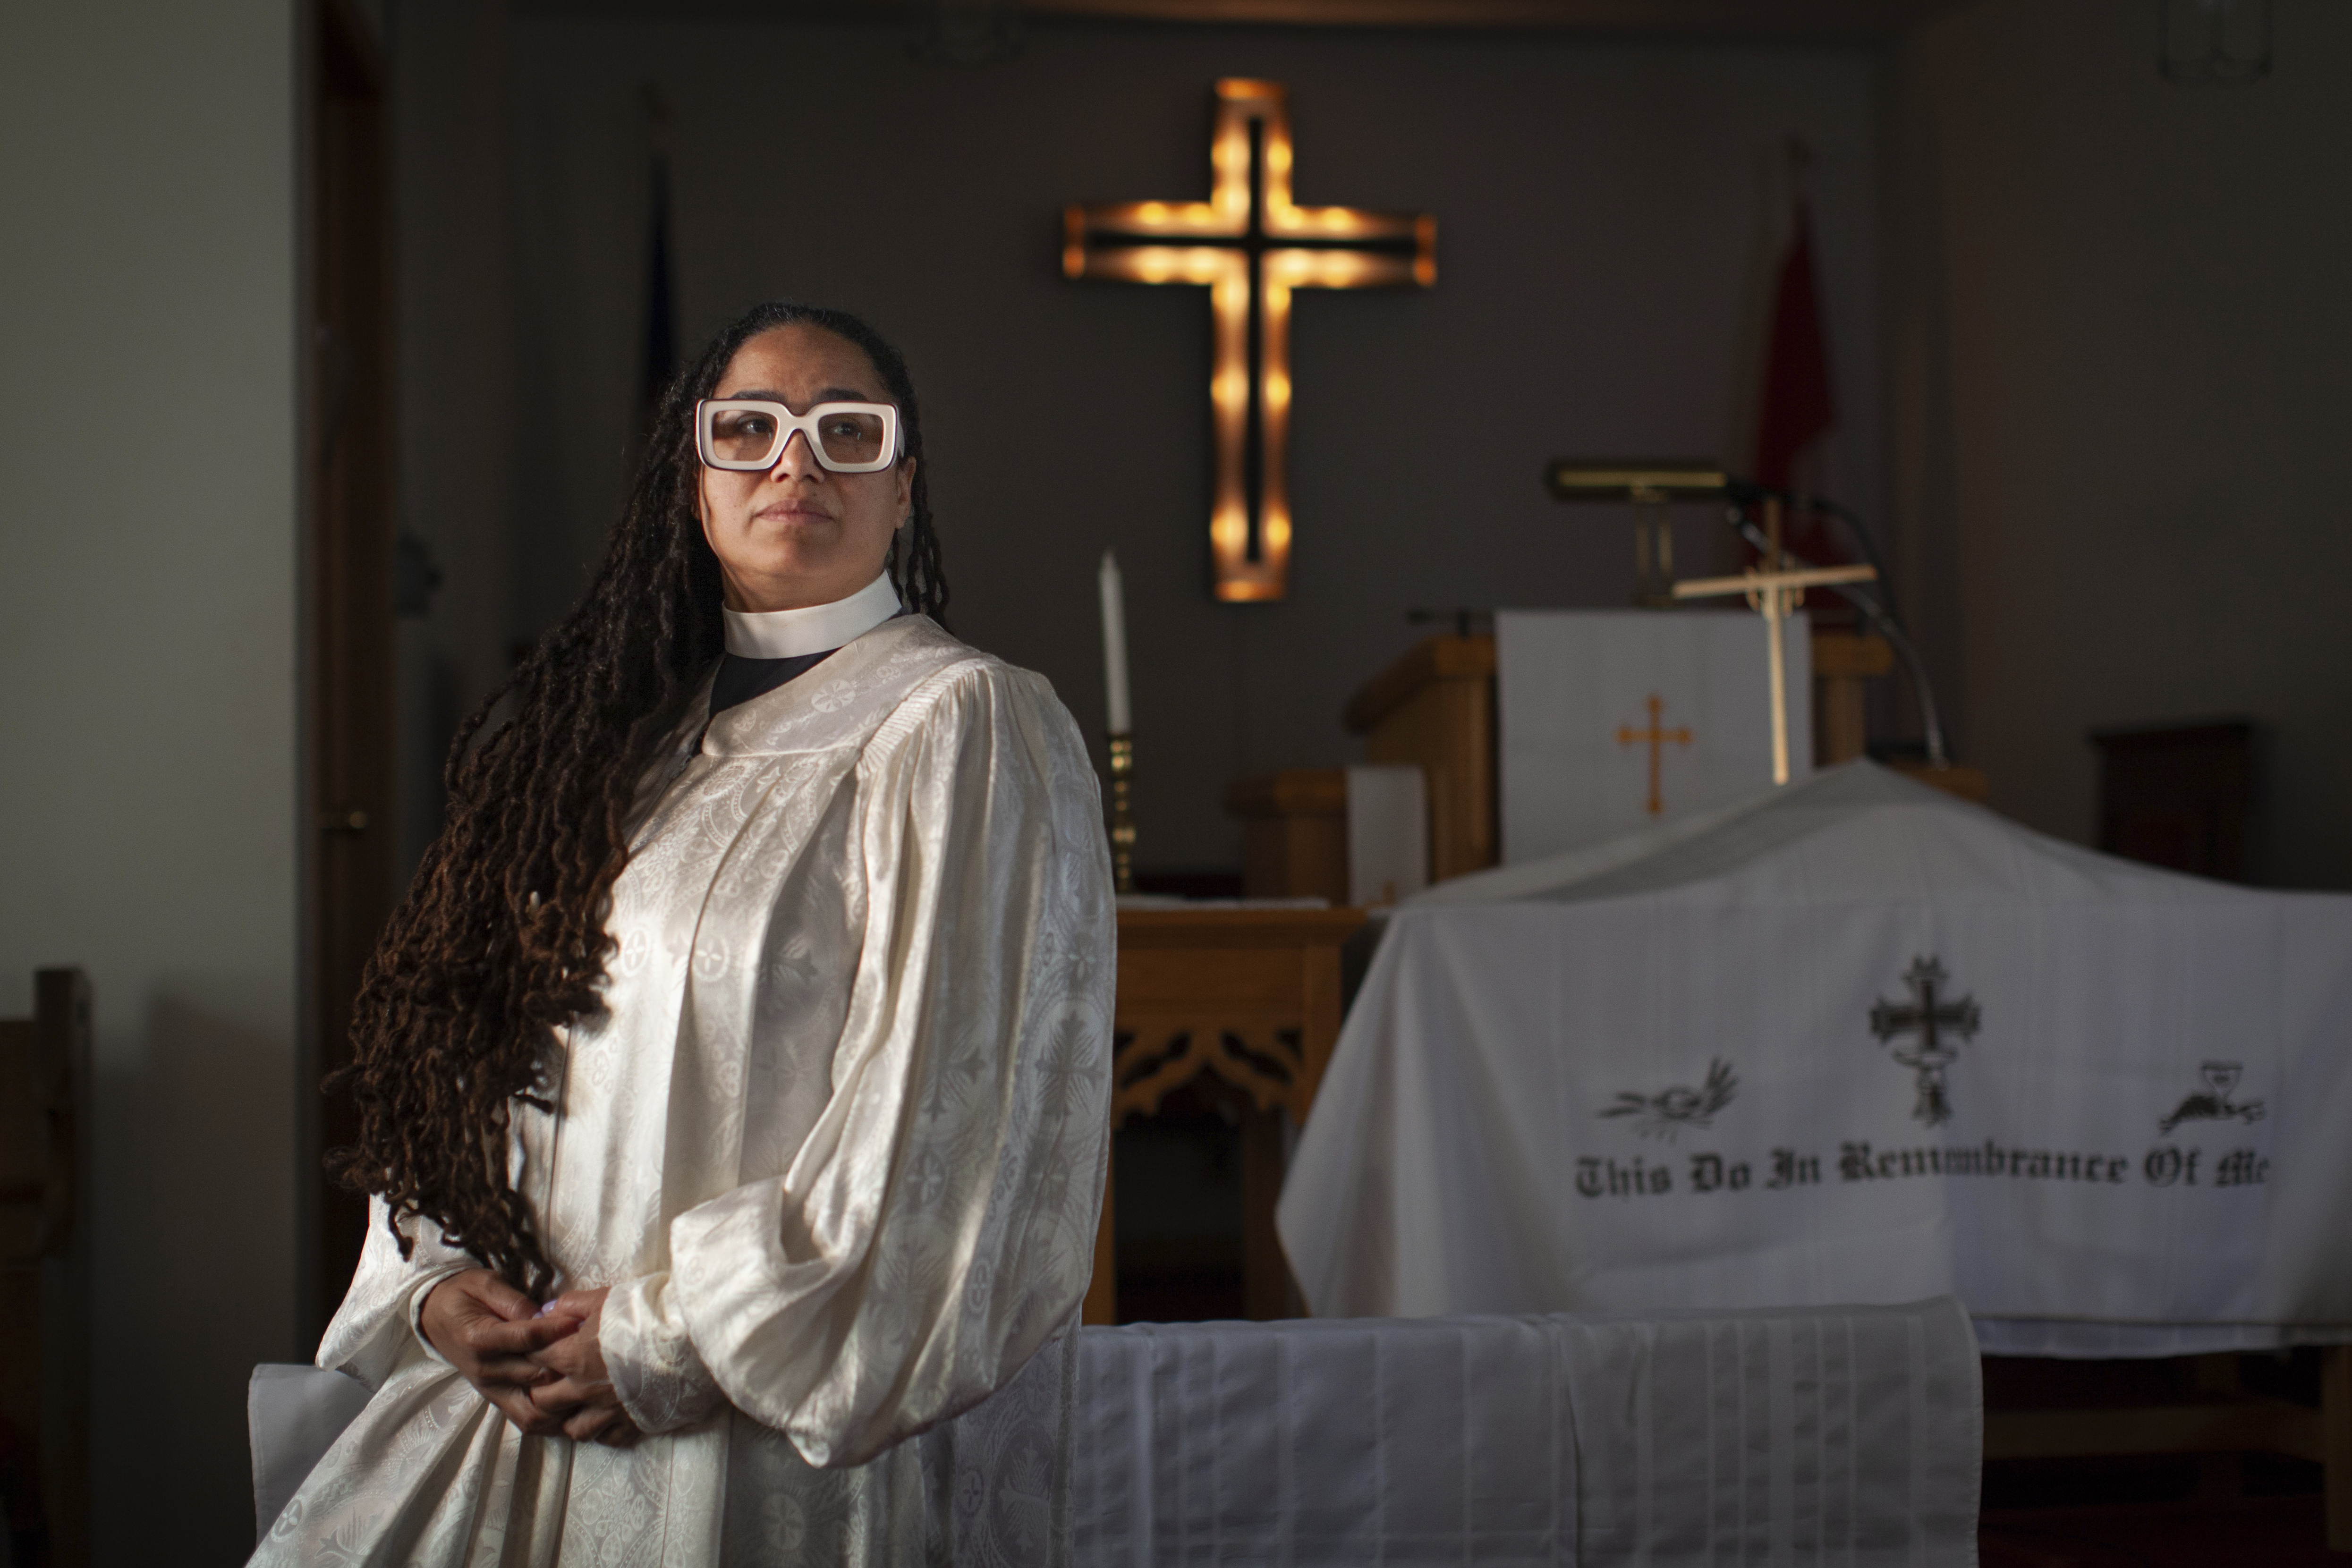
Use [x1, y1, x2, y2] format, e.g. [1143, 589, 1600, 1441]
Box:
[600, 665, 1115, 1465]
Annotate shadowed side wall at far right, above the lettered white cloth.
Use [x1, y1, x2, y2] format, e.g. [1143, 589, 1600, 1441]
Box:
[1889, 0, 2352, 889]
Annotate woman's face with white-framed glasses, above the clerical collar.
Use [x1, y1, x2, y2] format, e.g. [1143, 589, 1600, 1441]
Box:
[701, 322, 915, 611]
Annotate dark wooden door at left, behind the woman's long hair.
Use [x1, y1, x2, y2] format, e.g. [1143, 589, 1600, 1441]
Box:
[301, 0, 393, 1335]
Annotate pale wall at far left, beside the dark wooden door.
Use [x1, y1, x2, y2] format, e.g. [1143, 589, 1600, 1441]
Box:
[0, 0, 301, 1566]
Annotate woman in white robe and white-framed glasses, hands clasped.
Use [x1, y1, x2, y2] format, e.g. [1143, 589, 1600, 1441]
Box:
[254, 305, 1112, 1568]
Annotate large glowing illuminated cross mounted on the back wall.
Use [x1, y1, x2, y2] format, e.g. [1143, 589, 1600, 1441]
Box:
[1061, 77, 1437, 602]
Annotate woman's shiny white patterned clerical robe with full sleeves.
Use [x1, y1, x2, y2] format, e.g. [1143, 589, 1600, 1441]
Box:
[254, 616, 1115, 1568]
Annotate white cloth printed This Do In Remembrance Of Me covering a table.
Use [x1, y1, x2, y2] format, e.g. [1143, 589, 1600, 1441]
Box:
[1280, 762, 2352, 1354]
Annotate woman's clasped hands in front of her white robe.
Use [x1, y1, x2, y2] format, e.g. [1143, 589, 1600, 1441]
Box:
[419, 1270, 640, 1448]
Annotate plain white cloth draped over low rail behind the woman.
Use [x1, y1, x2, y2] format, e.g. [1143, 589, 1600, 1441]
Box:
[252, 1300, 1983, 1568]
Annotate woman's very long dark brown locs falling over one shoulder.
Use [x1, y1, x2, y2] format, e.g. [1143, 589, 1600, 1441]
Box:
[327, 303, 948, 1300]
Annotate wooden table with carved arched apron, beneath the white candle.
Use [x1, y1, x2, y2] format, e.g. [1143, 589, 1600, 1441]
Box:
[1084, 907, 1364, 1323]
